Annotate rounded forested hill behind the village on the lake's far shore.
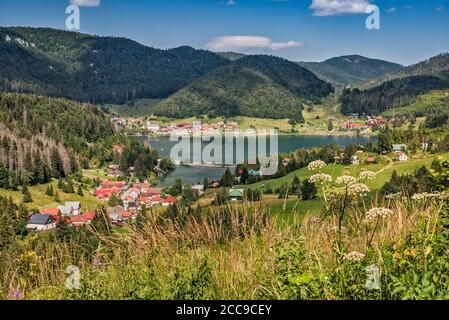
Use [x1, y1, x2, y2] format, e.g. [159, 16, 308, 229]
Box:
[156, 55, 333, 122]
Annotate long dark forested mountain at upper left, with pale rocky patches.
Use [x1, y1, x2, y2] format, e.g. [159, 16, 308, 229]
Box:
[0, 28, 228, 103]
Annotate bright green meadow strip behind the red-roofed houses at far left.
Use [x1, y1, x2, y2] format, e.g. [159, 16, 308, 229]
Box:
[0, 181, 101, 210]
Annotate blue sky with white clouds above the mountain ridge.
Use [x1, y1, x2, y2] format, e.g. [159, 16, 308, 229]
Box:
[0, 0, 449, 65]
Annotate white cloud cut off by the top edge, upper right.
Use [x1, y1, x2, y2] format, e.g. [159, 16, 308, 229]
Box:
[310, 0, 371, 17]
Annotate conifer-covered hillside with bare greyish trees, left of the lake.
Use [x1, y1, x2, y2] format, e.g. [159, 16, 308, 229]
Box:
[0, 93, 157, 188]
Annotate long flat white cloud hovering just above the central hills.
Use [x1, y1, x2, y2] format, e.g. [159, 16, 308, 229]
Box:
[206, 36, 302, 51]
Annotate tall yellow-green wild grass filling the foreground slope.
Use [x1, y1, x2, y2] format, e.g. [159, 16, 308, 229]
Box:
[1, 199, 447, 300]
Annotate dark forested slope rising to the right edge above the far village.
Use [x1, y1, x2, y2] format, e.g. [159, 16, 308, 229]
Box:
[340, 54, 449, 114]
